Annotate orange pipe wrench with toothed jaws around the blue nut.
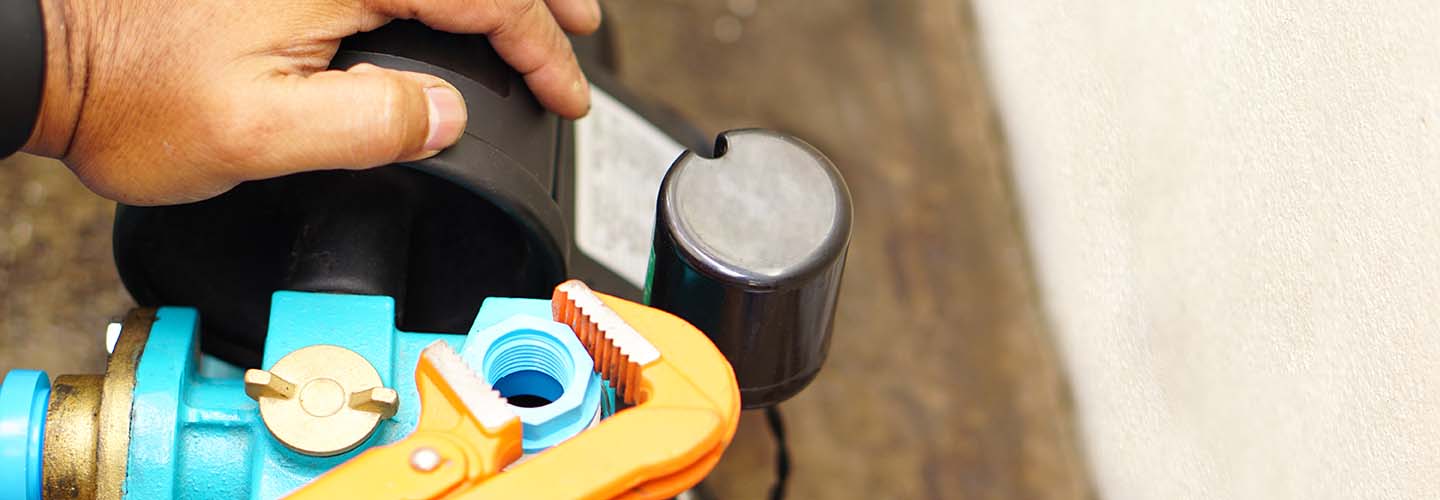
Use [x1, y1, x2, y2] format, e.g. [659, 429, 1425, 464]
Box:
[291, 280, 740, 499]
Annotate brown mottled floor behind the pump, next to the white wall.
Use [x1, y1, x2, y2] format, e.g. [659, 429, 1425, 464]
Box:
[0, 0, 1093, 499]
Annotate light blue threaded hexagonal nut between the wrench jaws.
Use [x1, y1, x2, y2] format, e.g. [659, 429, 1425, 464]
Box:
[461, 314, 602, 454]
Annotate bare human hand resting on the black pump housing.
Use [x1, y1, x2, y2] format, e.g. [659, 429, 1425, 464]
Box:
[26, 0, 600, 205]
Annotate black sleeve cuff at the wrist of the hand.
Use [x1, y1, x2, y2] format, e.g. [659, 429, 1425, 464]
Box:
[0, 0, 45, 159]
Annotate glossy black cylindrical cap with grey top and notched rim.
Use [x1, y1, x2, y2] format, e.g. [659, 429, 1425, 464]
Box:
[647, 130, 851, 408]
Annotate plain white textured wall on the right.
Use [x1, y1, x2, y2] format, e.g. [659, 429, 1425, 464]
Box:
[975, 0, 1440, 499]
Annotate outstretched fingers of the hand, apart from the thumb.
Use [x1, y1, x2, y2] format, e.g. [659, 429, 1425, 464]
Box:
[364, 0, 599, 118]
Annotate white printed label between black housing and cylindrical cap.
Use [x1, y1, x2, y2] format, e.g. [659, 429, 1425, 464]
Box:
[575, 86, 685, 288]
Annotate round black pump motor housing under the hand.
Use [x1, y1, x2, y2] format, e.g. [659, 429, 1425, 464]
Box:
[114, 22, 572, 366]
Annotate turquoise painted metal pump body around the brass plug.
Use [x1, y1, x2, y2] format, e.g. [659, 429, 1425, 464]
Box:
[125, 291, 561, 499]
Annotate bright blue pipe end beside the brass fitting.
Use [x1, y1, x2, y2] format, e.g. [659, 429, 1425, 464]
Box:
[0, 370, 50, 500]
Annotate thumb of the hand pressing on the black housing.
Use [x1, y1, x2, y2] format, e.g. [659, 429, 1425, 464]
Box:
[238, 65, 467, 179]
